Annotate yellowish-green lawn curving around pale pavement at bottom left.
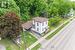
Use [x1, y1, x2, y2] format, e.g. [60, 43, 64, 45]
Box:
[0, 39, 19, 50]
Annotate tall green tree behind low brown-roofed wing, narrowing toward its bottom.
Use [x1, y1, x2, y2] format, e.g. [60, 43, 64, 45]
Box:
[15, 0, 34, 21]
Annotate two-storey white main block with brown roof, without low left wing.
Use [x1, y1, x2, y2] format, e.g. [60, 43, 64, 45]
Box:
[31, 17, 48, 33]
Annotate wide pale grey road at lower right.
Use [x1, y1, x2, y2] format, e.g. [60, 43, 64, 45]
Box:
[39, 20, 75, 50]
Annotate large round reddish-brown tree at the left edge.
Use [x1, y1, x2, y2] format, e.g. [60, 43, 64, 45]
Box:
[0, 12, 21, 39]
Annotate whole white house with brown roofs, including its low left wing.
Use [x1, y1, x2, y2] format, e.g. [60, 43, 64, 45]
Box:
[22, 17, 48, 34]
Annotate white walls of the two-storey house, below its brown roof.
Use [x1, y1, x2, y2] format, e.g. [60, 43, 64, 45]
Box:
[32, 21, 48, 34]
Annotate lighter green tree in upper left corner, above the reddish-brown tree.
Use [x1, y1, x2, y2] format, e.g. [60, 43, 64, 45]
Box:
[0, 0, 20, 16]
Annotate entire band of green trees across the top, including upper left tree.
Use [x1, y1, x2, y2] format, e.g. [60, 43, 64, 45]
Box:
[0, 0, 75, 21]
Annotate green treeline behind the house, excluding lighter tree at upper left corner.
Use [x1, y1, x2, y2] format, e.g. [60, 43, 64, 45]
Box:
[15, 0, 75, 21]
